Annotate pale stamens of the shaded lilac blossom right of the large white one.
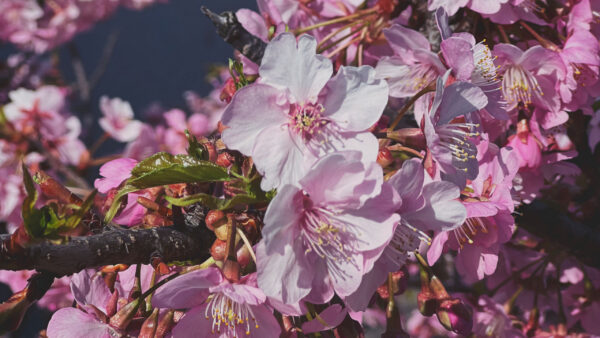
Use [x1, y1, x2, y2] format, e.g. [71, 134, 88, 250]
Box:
[436, 123, 479, 167]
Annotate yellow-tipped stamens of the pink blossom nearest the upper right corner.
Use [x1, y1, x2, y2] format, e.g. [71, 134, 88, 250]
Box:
[502, 66, 544, 104]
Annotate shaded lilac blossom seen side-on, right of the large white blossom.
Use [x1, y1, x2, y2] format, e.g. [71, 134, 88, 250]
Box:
[421, 70, 488, 188]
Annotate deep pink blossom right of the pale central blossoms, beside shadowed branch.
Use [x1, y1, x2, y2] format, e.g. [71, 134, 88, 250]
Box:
[427, 140, 519, 280]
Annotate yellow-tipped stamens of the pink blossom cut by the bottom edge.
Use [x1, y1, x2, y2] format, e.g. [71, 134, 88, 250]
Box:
[204, 293, 259, 337]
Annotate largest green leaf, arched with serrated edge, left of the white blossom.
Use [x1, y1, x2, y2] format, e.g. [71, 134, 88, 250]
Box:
[104, 152, 229, 223]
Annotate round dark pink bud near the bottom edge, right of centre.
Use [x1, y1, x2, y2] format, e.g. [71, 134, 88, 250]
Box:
[436, 298, 473, 336]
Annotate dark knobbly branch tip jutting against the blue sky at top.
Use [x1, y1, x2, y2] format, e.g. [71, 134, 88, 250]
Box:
[202, 6, 267, 65]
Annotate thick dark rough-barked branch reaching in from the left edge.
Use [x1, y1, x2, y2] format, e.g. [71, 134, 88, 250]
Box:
[0, 222, 214, 277]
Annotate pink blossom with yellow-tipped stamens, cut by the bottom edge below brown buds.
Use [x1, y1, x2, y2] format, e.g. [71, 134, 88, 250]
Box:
[152, 267, 281, 338]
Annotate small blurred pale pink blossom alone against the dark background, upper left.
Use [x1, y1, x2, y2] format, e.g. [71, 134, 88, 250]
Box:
[98, 96, 142, 142]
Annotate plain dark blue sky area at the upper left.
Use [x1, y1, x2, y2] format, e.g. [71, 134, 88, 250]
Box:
[60, 0, 256, 112]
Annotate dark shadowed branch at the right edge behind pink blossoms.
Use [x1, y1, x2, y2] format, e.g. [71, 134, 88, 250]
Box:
[516, 200, 600, 269]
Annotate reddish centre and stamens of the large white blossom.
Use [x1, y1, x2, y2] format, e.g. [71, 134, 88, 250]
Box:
[289, 103, 328, 140]
